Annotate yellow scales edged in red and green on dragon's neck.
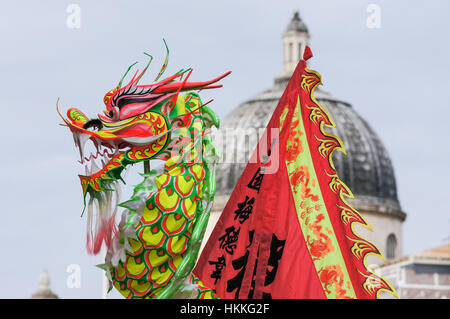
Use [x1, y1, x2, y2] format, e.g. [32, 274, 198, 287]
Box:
[111, 157, 209, 298]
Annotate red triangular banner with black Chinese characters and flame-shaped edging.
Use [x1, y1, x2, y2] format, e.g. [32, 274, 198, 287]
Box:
[194, 48, 395, 299]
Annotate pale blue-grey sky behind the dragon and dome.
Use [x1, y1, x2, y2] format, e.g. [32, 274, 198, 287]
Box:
[0, 0, 450, 298]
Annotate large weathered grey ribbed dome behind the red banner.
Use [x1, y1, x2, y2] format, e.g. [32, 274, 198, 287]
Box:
[216, 78, 406, 220]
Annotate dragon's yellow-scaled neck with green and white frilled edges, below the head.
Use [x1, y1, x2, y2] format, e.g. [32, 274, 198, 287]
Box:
[105, 93, 219, 298]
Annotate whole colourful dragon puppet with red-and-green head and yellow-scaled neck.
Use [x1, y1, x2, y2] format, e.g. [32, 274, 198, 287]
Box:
[57, 42, 230, 299]
